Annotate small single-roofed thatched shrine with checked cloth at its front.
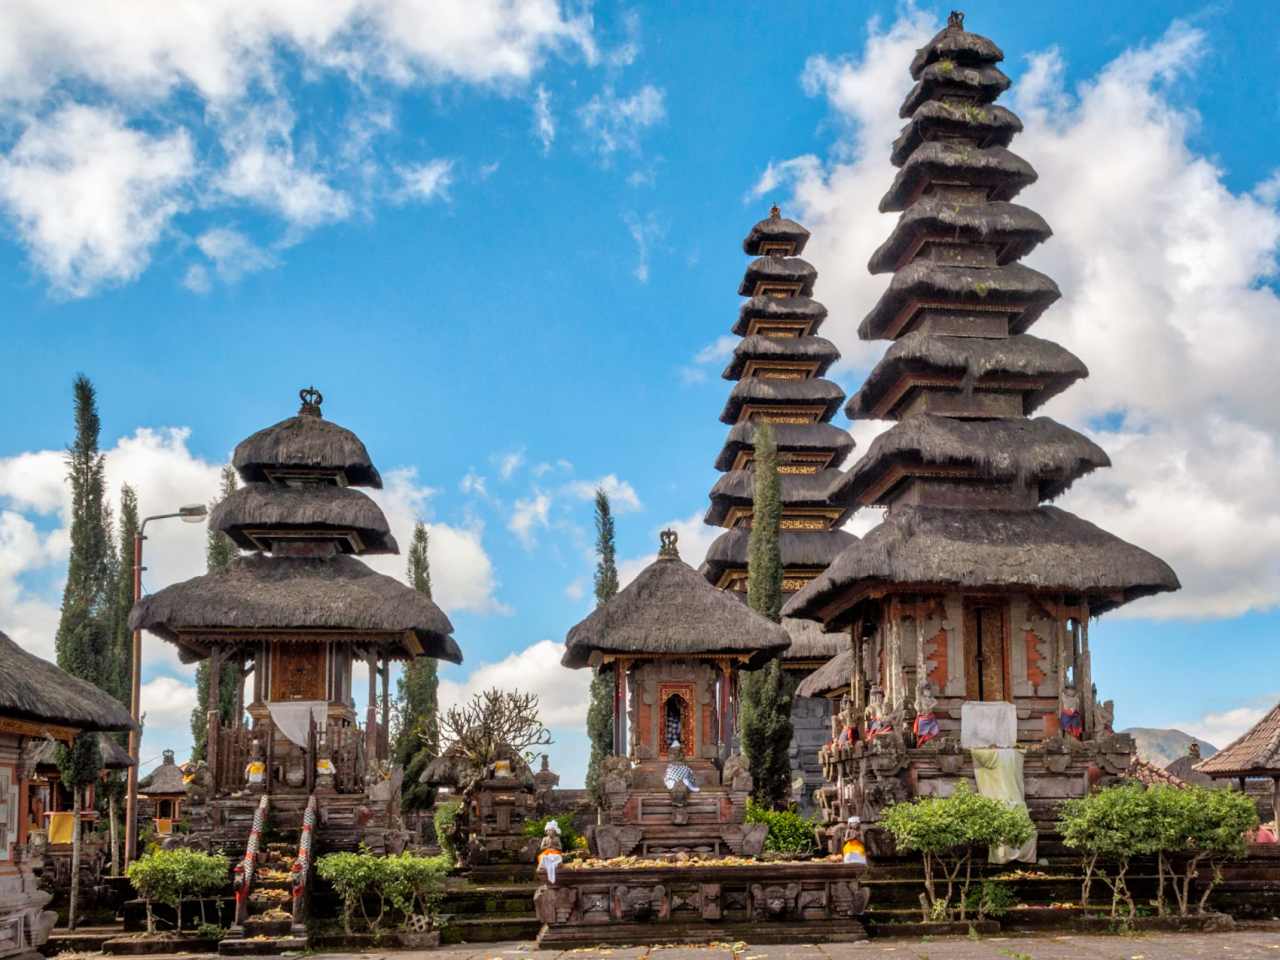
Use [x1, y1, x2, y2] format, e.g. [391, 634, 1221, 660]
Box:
[562, 530, 791, 859]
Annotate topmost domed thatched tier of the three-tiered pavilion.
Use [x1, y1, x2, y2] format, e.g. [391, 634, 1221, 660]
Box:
[232, 412, 383, 489]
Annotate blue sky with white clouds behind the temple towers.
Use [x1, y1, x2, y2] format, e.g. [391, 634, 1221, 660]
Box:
[0, 0, 1280, 782]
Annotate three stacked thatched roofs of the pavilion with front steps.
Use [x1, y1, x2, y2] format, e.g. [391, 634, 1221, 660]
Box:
[129, 389, 462, 663]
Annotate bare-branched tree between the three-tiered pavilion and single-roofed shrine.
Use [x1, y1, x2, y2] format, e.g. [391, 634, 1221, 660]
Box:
[440, 689, 552, 776]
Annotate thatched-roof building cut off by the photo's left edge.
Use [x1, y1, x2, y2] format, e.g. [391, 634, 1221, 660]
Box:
[0, 632, 133, 960]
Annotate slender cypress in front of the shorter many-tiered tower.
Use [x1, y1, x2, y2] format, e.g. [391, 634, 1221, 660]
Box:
[741, 422, 792, 808]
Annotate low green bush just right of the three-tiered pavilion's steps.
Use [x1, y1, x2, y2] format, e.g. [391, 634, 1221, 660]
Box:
[316, 854, 449, 936]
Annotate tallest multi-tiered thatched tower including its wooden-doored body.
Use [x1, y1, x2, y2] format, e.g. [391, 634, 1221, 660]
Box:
[785, 13, 1179, 819]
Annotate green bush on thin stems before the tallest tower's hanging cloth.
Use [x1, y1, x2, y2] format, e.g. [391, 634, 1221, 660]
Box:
[883, 781, 1033, 920]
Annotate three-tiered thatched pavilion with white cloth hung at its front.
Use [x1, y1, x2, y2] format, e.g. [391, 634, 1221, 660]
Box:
[131, 389, 462, 850]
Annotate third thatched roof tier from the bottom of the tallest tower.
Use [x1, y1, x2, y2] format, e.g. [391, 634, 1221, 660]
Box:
[845, 330, 1089, 420]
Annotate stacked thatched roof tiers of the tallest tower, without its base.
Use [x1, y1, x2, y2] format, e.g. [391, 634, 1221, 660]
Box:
[786, 13, 1179, 627]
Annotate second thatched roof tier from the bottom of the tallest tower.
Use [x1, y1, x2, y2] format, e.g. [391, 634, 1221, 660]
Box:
[831, 413, 1111, 503]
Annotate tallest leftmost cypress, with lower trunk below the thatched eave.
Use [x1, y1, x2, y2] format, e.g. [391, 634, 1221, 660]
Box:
[55, 374, 115, 928]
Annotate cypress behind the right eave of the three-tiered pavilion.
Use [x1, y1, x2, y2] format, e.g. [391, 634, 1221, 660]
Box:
[393, 521, 440, 810]
